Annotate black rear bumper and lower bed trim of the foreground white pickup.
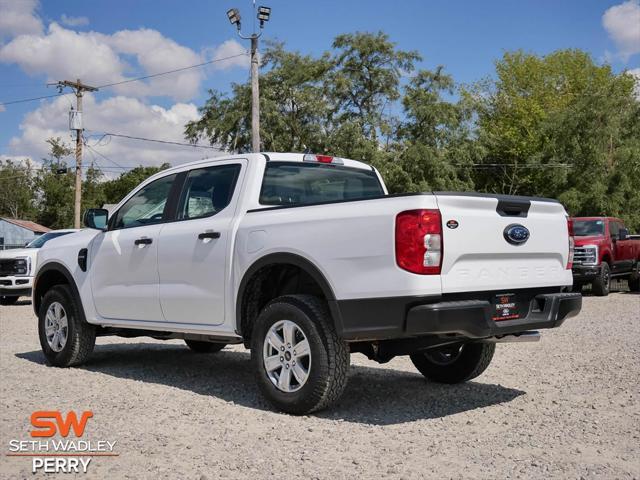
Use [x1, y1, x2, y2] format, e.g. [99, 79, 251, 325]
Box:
[332, 287, 582, 341]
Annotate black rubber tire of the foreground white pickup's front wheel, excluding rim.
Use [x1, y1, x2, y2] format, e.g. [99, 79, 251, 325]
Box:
[38, 285, 96, 367]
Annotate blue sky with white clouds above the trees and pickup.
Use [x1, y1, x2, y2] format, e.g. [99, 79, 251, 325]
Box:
[0, 0, 640, 169]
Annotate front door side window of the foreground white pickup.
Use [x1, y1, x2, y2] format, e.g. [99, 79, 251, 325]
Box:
[113, 174, 177, 228]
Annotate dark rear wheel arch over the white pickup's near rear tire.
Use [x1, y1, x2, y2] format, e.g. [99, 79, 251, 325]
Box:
[235, 253, 342, 344]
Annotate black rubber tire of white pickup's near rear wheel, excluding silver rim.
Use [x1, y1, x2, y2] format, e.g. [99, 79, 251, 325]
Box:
[251, 295, 350, 415]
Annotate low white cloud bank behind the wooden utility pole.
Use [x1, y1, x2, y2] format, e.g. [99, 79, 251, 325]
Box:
[7, 94, 216, 171]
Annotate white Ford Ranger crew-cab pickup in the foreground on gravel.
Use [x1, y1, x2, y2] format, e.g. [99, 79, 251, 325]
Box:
[33, 153, 582, 414]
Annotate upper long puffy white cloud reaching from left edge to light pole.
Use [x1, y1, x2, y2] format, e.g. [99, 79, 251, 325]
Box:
[0, 18, 248, 101]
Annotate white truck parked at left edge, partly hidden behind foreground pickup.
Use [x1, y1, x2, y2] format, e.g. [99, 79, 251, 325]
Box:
[0, 230, 77, 305]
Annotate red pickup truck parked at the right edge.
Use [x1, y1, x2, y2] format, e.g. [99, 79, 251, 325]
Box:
[572, 217, 640, 296]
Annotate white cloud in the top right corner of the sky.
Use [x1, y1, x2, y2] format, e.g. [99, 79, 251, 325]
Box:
[602, 0, 640, 61]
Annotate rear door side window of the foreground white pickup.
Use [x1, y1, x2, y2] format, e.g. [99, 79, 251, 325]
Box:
[178, 164, 241, 220]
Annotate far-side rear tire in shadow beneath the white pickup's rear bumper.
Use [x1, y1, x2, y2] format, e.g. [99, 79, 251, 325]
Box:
[411, 343, 496, 384]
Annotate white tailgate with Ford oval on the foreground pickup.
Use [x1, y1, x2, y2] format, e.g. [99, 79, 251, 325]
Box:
[435, 192, 572, 293]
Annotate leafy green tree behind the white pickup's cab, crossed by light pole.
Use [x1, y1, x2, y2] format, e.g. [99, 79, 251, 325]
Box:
[185, 33, 420, 161]
